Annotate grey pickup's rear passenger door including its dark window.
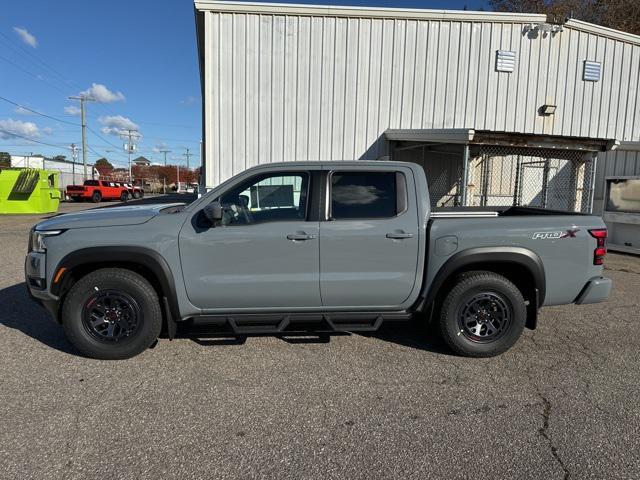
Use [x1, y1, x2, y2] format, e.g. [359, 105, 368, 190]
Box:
[320, 167, 420, 308]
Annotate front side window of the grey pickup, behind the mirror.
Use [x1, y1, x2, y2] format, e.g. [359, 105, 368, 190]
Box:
[219, 172, 309, 225]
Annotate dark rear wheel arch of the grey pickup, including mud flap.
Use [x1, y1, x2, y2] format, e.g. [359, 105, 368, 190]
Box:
[418, 247, 546, 329]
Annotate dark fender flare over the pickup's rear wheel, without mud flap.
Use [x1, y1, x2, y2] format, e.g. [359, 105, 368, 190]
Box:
[420, 247, 546, 307]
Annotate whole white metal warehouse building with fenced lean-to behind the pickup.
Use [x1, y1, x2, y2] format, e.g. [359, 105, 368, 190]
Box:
[195, 0, 640, 251]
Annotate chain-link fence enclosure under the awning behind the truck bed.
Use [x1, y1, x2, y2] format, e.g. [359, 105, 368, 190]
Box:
[393, 144, 595, 213]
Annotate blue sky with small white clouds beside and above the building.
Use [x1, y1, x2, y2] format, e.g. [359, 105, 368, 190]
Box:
[0, 0, 484, 166]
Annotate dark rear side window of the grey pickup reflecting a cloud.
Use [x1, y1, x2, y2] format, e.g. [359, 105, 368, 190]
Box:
[330, 172, 406, 220]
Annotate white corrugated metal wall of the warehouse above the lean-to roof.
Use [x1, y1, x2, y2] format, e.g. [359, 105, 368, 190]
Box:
[204, 6, 640, 186]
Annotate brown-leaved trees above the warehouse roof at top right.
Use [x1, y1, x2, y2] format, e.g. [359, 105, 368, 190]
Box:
[489, 0, 640, 35]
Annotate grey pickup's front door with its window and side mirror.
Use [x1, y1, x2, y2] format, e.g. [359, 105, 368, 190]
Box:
[180, 170, 321, 312]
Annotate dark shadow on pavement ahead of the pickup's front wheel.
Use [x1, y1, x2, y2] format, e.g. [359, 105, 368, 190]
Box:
[0, 282, 78, 355]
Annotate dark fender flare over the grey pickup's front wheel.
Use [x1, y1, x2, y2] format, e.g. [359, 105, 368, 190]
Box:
[51, 246, 180, 320]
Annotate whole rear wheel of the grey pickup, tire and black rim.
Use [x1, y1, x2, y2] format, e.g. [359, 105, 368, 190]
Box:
[439, 271, 527, 357]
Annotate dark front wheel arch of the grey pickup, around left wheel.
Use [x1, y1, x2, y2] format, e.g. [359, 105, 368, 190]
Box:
[51, 246, 180, 326]
